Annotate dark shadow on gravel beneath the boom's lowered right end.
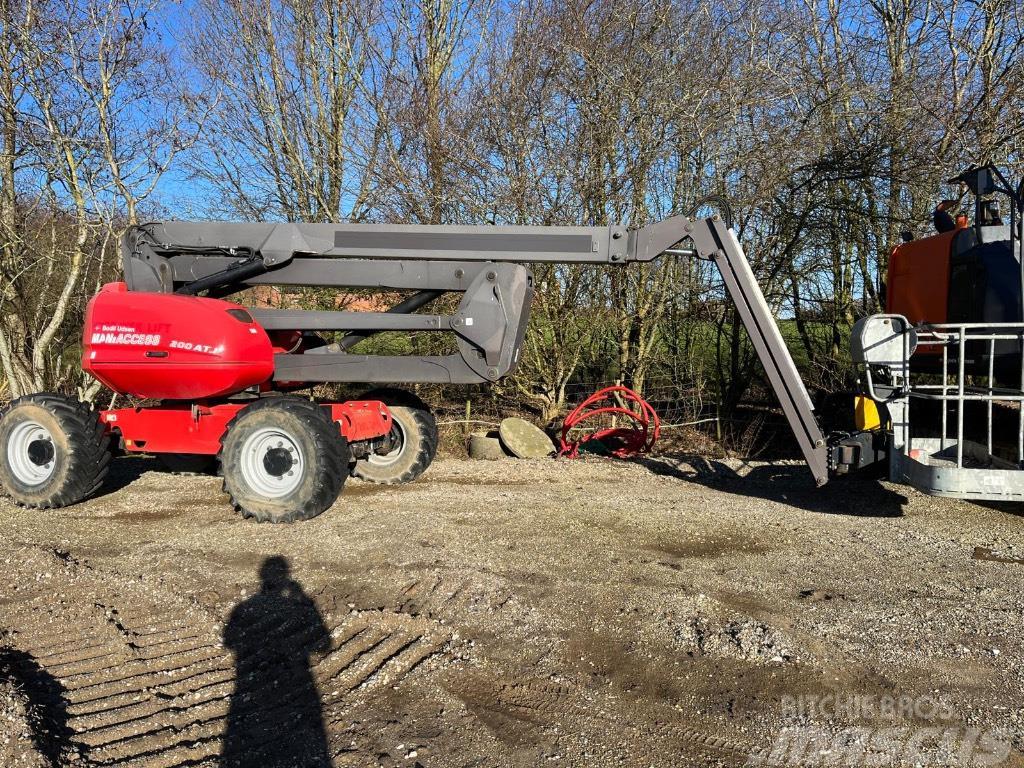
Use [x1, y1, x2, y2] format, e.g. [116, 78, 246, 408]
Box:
[632, 454, 907, 517]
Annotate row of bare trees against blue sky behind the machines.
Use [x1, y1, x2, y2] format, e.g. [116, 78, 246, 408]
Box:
[0, 0, 1024, 434]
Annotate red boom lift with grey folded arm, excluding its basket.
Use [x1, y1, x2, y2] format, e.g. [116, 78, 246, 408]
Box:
[0, 215, 828, 522]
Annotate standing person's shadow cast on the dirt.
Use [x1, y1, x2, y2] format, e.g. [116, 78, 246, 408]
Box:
[220, 556, 332, 768]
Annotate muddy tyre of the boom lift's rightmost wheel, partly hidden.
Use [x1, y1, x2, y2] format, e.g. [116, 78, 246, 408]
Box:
[352, 389, 437, 485]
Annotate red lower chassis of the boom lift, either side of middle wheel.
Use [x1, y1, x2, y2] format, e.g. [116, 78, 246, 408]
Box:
[99, 400, 391, 456]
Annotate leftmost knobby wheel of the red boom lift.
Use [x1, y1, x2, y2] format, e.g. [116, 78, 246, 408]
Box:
[0, 392, 111, 509]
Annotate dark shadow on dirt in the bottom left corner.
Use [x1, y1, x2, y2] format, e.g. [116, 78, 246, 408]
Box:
[0, 647, 80, 767]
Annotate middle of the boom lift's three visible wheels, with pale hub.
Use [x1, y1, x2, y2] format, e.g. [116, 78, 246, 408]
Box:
[218, 397, 348, 522]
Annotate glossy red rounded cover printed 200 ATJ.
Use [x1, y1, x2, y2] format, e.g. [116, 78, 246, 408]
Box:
[82, 283, 273, 400]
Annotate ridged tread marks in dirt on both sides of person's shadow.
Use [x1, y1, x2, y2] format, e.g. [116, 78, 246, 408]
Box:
[0, 548, 450, 768]
